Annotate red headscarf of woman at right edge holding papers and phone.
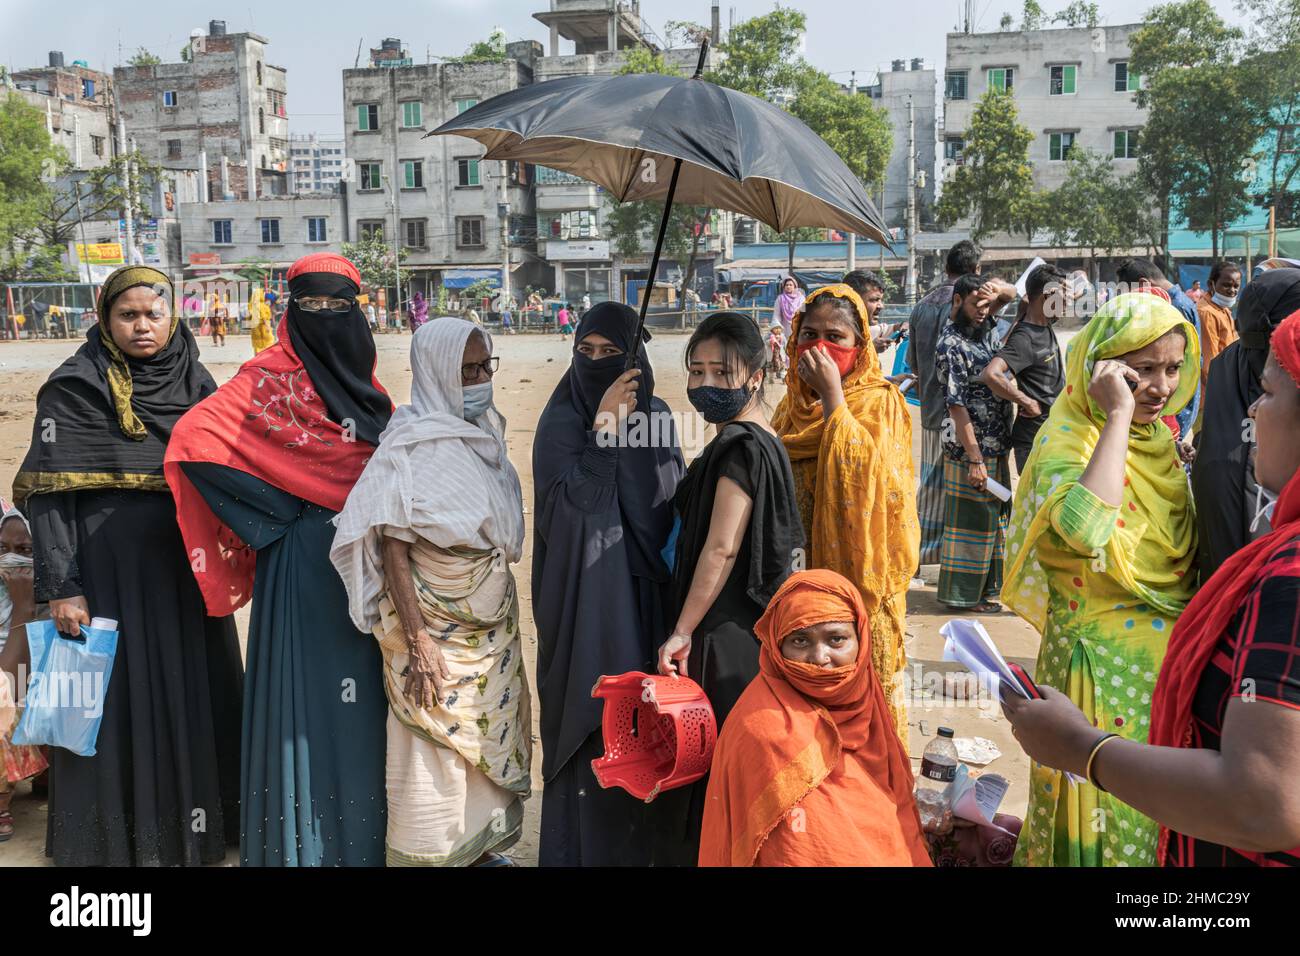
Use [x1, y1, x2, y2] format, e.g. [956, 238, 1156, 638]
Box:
[1148, 312, 1300, 864]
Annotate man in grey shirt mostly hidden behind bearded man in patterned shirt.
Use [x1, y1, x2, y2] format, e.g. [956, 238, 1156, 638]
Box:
[907, 239, 980, 564]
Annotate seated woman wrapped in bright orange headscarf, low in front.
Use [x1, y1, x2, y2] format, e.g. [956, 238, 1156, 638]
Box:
[699, 571, 931, 866]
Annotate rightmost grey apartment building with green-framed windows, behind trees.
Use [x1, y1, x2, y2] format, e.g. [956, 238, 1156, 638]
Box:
[943, 23, 1145, 201]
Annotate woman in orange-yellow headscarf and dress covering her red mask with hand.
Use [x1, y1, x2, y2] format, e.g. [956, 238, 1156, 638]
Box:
[772, 285, 920, 741]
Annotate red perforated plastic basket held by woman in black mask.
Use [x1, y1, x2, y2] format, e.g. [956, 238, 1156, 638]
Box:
[592, 671, 718, 804]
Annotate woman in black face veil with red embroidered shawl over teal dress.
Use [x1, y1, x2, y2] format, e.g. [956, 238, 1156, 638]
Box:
[165, 254, 393, 866]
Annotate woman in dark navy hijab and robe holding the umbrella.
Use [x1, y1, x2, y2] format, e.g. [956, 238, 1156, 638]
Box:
[533, 302, 685, 866]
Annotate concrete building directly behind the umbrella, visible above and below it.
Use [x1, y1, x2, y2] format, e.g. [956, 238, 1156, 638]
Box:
[533, 0, 731, 302]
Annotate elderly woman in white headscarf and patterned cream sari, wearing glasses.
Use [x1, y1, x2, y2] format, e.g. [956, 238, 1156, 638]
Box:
[330, 319, 532, 866]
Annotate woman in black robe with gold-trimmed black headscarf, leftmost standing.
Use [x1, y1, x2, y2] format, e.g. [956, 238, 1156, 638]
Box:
[14, 267, 243, 866]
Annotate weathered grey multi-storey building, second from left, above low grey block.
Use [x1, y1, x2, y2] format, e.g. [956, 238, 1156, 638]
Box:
[113, 20, 289, 200]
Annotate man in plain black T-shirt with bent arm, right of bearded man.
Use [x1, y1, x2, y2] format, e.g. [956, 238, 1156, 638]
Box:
[979, 265, 1069, 473]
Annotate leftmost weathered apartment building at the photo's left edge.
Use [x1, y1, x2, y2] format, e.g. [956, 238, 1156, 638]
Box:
[10, 51, 117, 172]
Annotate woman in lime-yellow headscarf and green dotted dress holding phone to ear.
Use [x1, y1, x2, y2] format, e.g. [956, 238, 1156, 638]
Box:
[1002, 293, 1200, 866]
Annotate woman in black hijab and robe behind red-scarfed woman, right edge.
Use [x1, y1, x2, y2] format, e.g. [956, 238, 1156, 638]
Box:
[1192, 269, 1300, 583]
